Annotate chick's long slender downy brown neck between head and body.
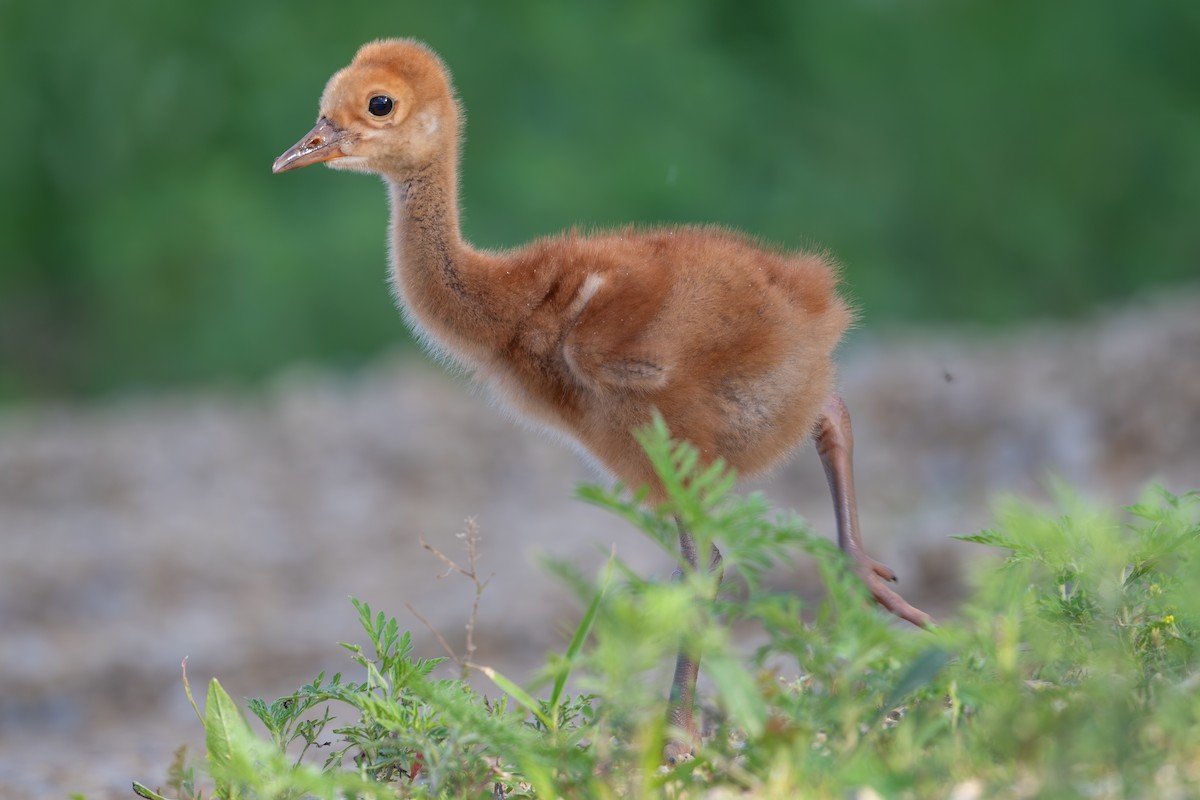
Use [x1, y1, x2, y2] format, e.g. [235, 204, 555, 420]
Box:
[386, 156, 508, 363]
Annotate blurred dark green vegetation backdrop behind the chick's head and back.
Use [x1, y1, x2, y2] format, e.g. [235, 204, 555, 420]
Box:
[0, 0, 1200, 401]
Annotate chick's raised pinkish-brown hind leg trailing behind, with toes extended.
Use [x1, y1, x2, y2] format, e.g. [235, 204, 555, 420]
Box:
[812, 395, 932, 627]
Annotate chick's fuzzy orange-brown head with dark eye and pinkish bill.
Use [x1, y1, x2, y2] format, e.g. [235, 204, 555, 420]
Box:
[271, 40, 458, 180]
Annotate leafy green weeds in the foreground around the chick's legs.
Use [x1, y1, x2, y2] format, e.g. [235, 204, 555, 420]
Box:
[136, 421, 1200, 800]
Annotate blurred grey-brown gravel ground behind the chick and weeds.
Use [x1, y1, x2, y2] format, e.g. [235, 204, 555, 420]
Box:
[0, 291, 1200, 798]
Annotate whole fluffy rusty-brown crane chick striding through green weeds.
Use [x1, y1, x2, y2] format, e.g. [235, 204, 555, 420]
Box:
[275, 40, 928, 762]
